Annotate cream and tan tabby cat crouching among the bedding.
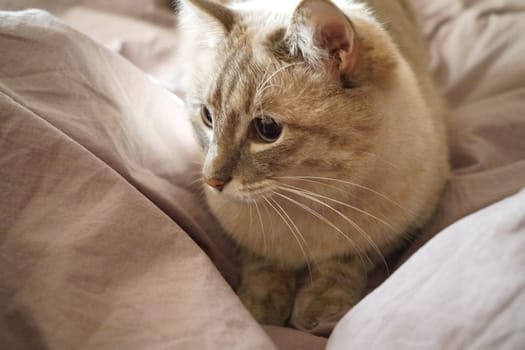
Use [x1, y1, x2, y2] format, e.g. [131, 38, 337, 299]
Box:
[179, 0, 449, 329]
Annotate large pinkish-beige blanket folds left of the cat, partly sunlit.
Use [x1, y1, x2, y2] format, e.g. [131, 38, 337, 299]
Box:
[0, 12, 274, 349]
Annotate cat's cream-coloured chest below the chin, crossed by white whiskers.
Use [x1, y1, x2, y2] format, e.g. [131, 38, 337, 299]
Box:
[207, 194, 381, 268]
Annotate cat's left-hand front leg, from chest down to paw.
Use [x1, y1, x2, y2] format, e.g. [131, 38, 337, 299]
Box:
[237, 252, 295, 326]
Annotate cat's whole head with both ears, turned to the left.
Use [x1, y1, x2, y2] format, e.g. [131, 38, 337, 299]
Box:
[181, 0, 397, 200]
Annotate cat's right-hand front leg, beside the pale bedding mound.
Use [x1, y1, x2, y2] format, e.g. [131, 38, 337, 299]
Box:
[292, 257, 369, 329]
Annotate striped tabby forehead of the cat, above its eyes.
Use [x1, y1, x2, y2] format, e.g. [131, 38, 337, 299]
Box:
[201, 22, 340, 128]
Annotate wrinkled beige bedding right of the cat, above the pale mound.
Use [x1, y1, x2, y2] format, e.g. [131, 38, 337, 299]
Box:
[405, 0, 525, 258]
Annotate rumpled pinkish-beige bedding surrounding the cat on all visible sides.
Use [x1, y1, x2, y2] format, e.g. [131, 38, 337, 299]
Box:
[0, 0, 525, 350]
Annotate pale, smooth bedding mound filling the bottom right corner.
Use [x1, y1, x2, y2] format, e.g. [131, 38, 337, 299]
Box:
[327, 190, 525, 350]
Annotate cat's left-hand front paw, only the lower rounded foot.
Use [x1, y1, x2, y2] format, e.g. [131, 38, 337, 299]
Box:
[238, 288, 293, 326]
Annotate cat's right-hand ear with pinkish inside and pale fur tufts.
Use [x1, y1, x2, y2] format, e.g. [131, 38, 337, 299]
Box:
[286, 0, 358, 75]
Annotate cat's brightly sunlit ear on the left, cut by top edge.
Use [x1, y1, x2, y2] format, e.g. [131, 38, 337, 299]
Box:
[179, 0, 237, 47]
